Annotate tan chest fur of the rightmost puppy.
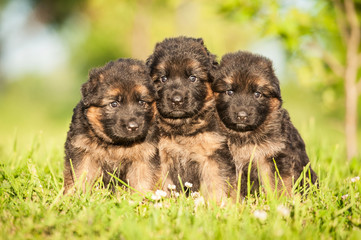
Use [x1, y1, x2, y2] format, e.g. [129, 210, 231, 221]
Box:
[228, 141, 285, 168]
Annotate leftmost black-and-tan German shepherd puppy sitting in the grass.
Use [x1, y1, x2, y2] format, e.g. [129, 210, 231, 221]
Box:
[64, 59, 160, 193]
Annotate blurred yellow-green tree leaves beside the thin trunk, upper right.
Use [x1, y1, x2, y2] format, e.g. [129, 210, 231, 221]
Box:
[218, 0, 361, 124]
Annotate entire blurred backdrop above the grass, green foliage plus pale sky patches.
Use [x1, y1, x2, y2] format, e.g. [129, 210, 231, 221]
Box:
[0, 0, 361, 159]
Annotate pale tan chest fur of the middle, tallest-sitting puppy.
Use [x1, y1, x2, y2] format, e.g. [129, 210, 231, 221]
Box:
[158, 132, 226, 165]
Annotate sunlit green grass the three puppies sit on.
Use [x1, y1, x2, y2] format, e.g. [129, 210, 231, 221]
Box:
[0, 84, 361, 240]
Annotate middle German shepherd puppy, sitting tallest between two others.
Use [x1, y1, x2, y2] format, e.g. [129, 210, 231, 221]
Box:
[147, 37, 236, 201]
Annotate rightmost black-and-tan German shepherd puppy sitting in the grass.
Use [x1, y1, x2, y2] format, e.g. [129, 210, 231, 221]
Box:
[212, 51, 317, 196]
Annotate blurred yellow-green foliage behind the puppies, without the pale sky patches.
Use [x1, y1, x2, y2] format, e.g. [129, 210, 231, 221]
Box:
[0, 0, 361, 150]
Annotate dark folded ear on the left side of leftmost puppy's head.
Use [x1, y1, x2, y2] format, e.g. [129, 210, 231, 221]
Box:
[81, 68, 104, 107]
